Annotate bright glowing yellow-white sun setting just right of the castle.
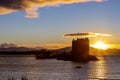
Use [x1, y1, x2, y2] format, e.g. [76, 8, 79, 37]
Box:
[91, 41, 110, 50]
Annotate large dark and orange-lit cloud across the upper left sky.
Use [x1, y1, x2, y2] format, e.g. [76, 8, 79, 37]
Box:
[0, 0, 106, 18]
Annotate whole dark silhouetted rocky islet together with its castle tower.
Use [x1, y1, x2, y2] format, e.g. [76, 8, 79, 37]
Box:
[36, 38, 98, 62]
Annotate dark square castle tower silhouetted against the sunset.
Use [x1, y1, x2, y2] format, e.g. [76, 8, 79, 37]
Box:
[72, 38, 89, 61]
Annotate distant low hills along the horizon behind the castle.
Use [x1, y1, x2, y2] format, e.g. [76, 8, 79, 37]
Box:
[0, 46, 120, 54]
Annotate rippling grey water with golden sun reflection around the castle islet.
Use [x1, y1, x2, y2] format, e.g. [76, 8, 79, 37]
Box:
[0, 55, 120, 80]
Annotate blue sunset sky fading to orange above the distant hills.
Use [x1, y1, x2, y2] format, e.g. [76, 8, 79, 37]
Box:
[0, 0, 120, 49]
